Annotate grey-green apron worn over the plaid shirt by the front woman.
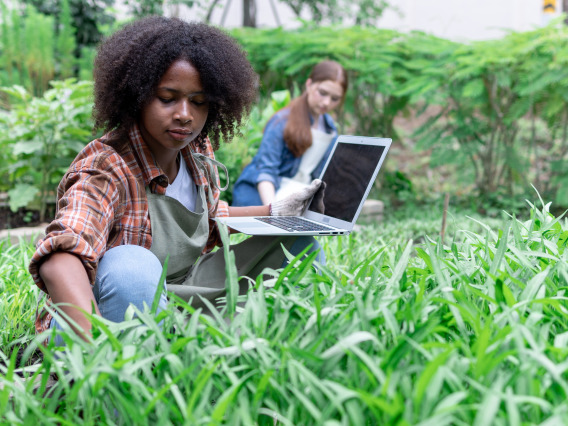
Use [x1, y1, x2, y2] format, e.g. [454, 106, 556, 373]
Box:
[146, 158, 296, 308]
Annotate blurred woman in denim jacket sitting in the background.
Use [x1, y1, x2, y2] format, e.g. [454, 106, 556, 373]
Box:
[233, 61, 348, 206]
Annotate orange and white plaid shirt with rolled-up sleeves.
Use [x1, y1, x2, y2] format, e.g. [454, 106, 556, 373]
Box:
[29, 126, 229, 331]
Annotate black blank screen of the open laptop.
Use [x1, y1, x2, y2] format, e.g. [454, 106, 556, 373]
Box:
[308, 142, 385, 222]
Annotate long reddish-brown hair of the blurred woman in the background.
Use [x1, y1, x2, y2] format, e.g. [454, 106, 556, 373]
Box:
[284, 61, 348, 157]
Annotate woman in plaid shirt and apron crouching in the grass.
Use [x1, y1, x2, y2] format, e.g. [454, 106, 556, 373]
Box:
[29, 17, 323, 343]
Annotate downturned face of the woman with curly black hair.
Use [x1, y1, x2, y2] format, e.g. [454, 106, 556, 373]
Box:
[139, 59, 209, 158]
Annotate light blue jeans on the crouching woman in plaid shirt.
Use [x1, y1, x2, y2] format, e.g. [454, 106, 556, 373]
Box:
[51, 237, 325, 346]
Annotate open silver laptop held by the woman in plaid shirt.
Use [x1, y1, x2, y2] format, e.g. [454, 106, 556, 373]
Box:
[216, 135, 392, 235]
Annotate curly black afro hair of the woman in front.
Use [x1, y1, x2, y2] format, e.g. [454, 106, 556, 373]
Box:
[93, 16, 258, 149]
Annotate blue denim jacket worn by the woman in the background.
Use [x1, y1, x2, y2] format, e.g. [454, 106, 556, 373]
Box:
[233, 108, 337, 206]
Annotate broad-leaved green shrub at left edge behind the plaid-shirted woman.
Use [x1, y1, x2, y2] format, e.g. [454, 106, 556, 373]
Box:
[0, 79, 92, 220]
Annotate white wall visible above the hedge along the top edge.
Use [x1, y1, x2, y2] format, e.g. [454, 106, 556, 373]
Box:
[172, 0, 562, 41]
